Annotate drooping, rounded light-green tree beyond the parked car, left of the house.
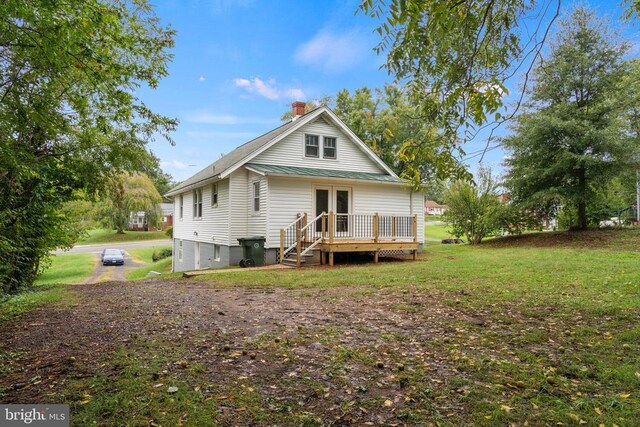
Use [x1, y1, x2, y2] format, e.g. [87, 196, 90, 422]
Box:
[99, 172, 162, 234]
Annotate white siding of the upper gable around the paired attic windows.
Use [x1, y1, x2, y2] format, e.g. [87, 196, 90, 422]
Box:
[251, 119, 384, 173]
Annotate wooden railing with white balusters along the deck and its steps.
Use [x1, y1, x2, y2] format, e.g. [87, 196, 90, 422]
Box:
[280, 212, 418, 265]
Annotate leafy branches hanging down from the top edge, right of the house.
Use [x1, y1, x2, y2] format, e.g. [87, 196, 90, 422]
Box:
[359, 0, 640, 184]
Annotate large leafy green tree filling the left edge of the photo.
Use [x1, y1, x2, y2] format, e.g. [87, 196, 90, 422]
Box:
[0, 0, 176, 292]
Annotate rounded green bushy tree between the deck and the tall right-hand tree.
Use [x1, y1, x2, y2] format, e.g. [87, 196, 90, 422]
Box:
[444, 168, 506, 245]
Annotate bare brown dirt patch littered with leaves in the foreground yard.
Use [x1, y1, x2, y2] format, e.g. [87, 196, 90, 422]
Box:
[0, 279, 477, 425]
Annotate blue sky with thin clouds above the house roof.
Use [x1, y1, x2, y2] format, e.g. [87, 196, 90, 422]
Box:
[139, 0, 637, 181]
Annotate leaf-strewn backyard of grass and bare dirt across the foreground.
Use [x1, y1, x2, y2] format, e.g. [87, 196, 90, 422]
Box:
[0, 229, 640, 427]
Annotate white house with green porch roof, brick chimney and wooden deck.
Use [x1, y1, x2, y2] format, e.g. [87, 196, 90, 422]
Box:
[167, 102, 424, 271]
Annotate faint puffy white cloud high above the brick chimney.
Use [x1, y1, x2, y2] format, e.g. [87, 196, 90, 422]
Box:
[295, 29, 372, 73]
